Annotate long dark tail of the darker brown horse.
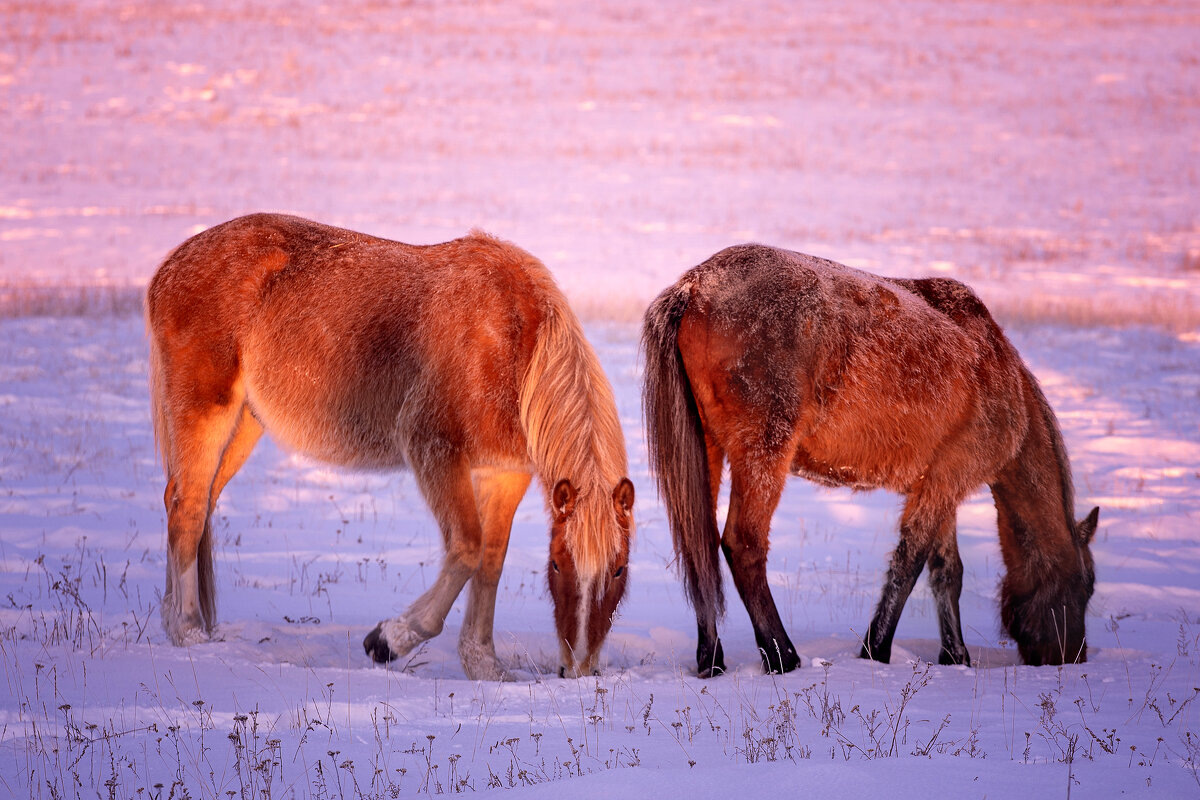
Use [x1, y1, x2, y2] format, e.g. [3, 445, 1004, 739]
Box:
[642, 281, 725, 615]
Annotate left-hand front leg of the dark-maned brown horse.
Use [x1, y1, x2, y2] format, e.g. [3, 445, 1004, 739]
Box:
[859, 497, 961, 663]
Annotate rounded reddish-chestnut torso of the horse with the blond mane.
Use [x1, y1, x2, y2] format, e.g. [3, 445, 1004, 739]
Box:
[148, 215, 557, 468]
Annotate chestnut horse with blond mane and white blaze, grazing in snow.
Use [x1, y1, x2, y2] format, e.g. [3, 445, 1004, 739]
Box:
[146, 215, 634, 679]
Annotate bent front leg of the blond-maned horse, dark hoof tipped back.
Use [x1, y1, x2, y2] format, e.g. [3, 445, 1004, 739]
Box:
[362, 447, 482, 663]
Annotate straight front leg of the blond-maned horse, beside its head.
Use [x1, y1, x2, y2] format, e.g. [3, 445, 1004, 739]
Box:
[458, 473, 532, 680]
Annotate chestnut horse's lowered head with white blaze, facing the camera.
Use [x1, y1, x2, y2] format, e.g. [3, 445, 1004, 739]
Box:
[546, 477, 634, 678]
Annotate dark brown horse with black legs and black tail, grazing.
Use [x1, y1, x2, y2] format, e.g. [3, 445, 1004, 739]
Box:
[642, 245, 1099, 678]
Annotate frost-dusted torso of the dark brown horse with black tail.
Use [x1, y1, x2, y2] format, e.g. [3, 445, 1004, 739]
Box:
[679, 245, 1019, 491]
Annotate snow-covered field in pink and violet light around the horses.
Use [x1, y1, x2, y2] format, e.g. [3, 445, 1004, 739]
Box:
[0, 0, 1200, 799]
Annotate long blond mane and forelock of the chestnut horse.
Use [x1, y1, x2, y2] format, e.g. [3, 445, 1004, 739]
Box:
[520, 290, 628, 579]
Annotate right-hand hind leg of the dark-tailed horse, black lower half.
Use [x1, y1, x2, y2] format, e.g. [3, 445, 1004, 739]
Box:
[721, 465, 800, 673]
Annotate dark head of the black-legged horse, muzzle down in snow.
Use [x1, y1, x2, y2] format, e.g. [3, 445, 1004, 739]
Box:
[1001, 509, 1100, 667]
